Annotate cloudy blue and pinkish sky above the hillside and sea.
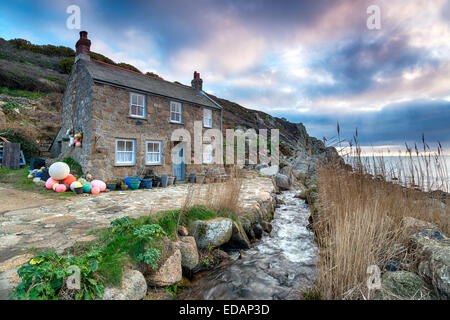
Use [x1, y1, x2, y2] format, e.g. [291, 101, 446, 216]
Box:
[0, 0, 450, 152]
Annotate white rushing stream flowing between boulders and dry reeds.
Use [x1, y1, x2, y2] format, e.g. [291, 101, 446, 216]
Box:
[179, 191, 317, 300]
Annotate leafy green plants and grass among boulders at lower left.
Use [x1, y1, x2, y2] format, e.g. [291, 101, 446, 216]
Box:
[11, 217, 166, 300]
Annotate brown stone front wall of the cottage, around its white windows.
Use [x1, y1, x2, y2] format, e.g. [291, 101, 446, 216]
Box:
[83, 83, 220, 180]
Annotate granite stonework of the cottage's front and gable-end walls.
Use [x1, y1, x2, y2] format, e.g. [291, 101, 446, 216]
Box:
[51, 60, 223, 181]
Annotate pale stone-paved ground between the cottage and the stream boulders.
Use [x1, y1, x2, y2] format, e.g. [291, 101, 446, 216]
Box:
[0, 176, 274, 299]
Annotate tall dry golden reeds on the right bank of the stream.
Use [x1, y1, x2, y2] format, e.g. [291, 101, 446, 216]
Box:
[314, 135, 450, 299]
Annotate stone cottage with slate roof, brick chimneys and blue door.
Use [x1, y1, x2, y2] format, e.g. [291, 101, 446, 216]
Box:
[51, 31, 222, 180]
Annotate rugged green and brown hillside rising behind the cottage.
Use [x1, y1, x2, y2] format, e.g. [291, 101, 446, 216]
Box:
[0, 38, 327, 159]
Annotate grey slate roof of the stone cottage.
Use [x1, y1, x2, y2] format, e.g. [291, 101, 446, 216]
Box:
[83, 59, 222, 109]
